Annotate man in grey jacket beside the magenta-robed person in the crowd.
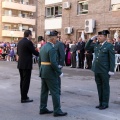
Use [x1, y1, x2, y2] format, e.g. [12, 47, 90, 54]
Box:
[70, 40, 77, 68]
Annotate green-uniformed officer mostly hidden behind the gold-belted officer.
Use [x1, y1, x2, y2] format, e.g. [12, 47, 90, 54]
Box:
[55, 35, 65, 95]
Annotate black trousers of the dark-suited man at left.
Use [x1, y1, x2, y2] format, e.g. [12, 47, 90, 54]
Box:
[19, 69, 31, 100]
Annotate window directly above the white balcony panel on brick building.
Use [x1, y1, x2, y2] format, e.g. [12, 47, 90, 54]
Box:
[46, 5, 62, 17]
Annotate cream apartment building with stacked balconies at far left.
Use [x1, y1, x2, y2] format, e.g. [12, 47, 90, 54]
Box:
[0, 0, 36, 42]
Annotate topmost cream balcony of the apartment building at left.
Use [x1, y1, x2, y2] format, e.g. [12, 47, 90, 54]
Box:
[2, 1, 36, 12]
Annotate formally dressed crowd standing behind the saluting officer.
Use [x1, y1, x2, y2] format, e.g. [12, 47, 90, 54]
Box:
[58, 36, 120, 69]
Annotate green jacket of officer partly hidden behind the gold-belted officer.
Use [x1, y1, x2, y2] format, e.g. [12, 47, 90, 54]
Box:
[55, 41, 65, 66]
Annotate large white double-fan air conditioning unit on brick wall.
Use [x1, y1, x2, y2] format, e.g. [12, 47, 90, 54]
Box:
[85, 19, 95, 33]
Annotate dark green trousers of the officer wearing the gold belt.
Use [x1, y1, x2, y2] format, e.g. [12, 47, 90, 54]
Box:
[40, 78, 61, 114]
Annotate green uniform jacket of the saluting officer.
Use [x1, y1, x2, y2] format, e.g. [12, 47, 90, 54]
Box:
[85, 40, 115, 73]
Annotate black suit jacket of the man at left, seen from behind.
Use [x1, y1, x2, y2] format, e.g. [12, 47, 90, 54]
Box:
[17, 38, 39, 69]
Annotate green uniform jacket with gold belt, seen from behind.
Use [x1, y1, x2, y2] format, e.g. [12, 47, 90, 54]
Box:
[39, 42, 62, 79]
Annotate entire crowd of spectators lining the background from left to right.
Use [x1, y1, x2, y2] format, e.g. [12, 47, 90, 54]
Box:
[0, 33, 120, 69]
